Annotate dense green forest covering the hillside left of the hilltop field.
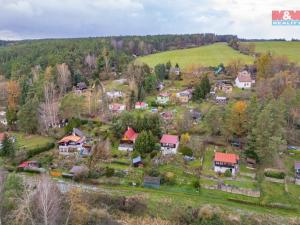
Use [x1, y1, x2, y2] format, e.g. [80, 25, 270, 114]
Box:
[0, 34, 237, 78]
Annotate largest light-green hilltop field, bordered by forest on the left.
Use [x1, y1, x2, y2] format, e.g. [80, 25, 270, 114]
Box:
[137, 43, 253, 69]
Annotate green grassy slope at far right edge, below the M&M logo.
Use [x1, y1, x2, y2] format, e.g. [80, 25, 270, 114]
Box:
[250, 41, 300, 63]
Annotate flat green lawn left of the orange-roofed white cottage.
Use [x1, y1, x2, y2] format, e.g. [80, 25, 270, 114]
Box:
[9, 132, 54, 150]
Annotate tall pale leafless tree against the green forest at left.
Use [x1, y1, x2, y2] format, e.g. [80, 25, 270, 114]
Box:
[56, 63, 71, 96]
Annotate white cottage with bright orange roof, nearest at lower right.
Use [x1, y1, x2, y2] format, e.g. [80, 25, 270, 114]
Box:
[214, 152, 240, 175]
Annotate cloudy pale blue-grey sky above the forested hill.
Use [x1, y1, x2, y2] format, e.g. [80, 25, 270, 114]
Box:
[0, 0, 300, 40]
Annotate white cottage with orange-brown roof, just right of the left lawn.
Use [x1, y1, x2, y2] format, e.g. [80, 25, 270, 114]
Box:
[58, 129, 85, 155]
